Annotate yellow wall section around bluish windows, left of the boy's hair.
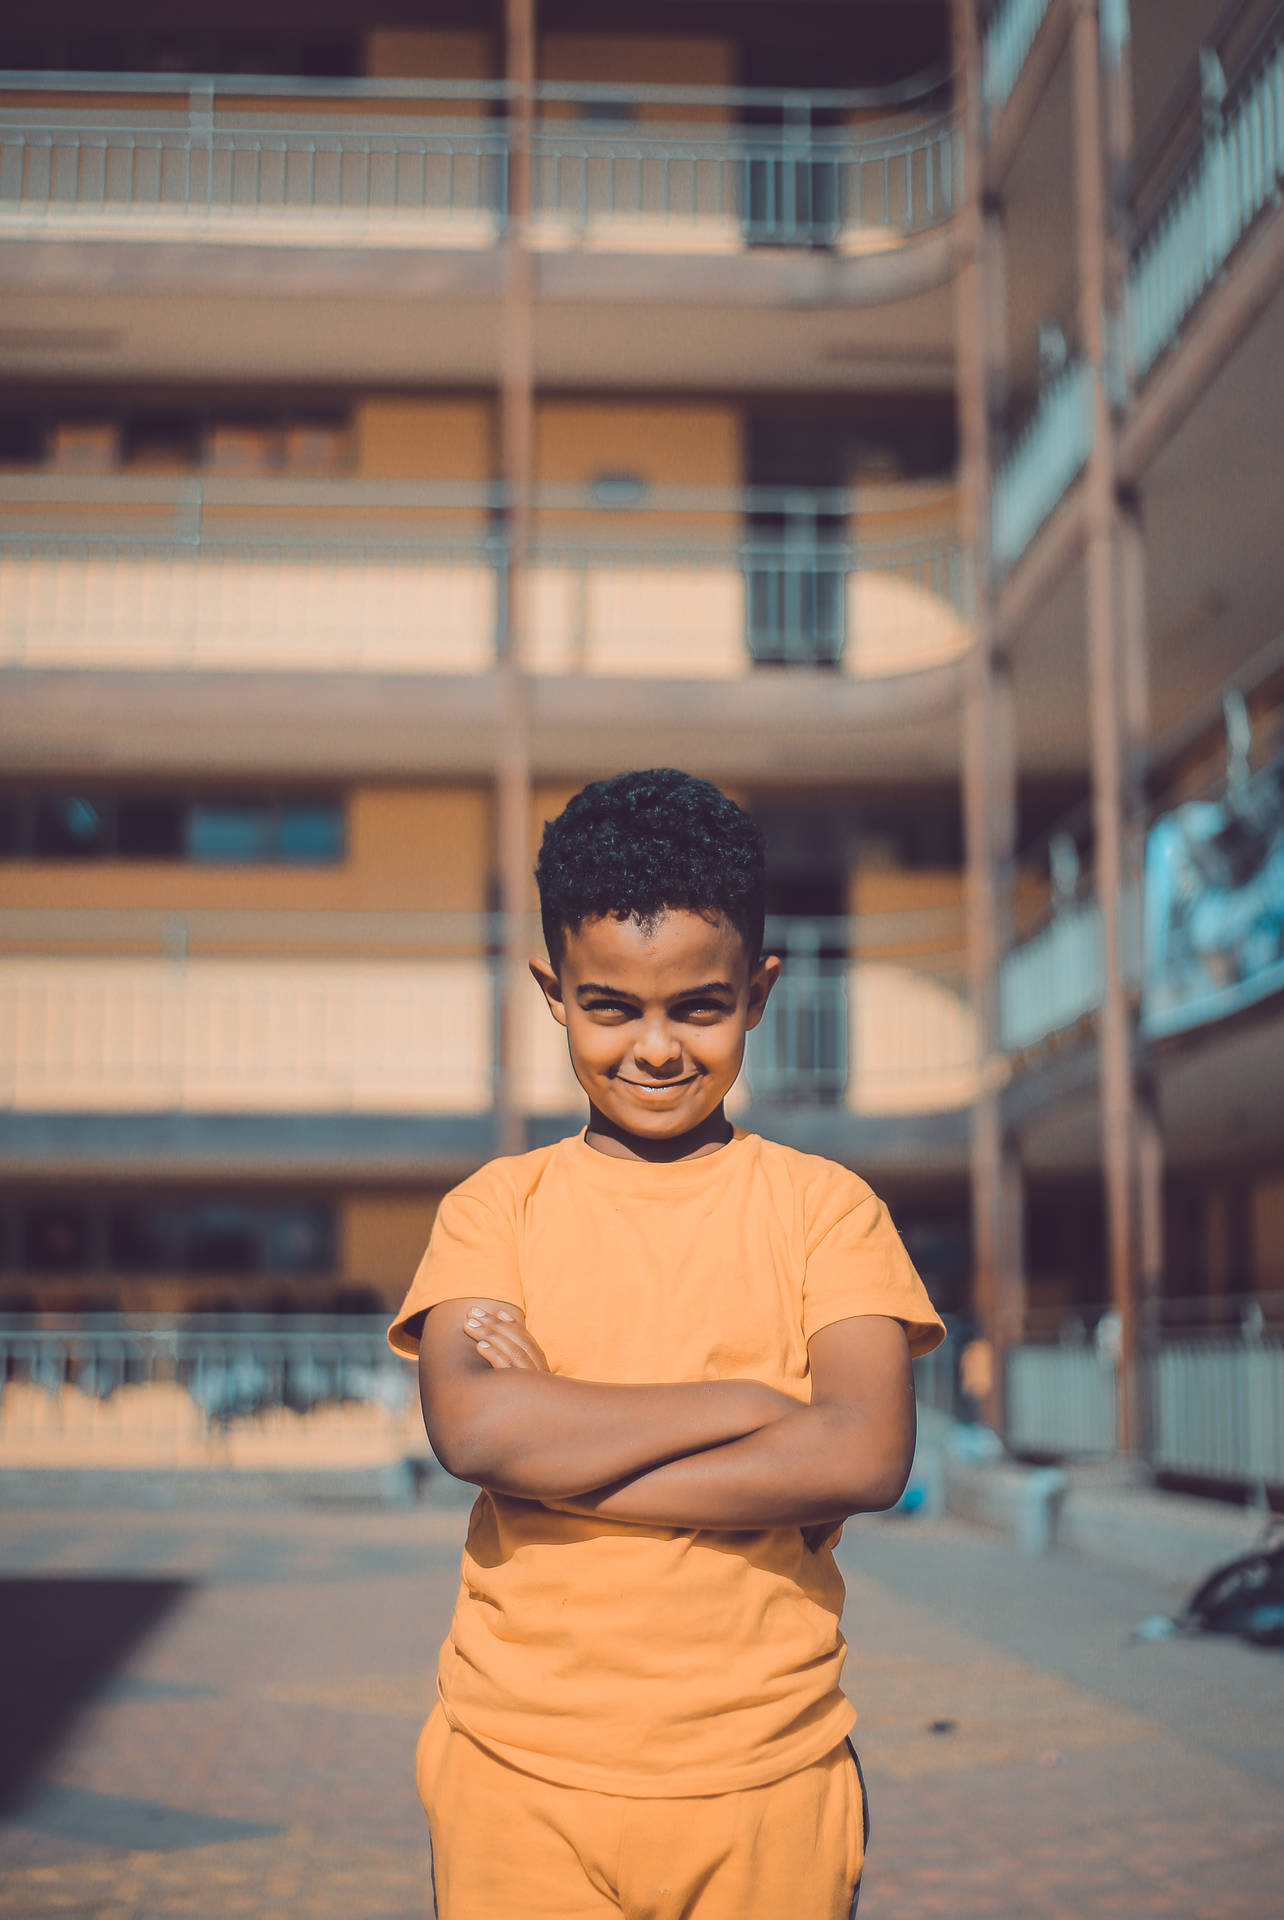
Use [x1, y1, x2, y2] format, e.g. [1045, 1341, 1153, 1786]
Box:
[2, 787, 491, 914]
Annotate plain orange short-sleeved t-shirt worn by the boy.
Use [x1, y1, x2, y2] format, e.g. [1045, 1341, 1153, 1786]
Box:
[390, 1131, 944, 1797]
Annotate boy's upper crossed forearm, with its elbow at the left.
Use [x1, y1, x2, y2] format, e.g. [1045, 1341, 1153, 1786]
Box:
[428, 1369, 797, 1500]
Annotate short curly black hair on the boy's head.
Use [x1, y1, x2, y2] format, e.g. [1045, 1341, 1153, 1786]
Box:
[535, 766, 766, 966]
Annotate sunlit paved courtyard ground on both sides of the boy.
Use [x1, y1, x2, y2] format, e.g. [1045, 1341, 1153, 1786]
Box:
[0, 1482, 1284, 1920]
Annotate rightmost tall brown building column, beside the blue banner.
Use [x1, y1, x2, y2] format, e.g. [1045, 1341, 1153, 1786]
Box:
[1071, 0, 1144, 1453]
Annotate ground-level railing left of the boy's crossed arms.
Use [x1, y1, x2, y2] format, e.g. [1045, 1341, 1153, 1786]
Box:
[0, 1313, 424, 1471]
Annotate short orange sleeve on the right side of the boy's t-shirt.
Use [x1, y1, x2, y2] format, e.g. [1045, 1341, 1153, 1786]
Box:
[802, 1181, 944, 1359]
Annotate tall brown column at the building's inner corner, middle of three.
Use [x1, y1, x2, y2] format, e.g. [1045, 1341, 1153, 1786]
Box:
[952, 0, 1023, 1427]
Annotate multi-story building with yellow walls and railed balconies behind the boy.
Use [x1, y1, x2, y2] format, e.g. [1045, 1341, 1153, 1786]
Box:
[0, 0, 1284, 1497]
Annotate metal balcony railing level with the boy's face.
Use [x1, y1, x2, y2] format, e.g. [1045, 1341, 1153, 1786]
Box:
[0, 910, 977, 1116]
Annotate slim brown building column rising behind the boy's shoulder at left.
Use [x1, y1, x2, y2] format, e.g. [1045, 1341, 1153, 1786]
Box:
[495, 0, 535, 1154]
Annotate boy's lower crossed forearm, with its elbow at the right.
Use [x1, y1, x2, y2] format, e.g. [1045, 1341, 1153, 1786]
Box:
[548, 1405, 914, 1530]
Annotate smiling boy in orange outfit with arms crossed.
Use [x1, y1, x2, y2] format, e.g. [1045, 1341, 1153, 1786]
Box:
[390, 770, 942, 1920]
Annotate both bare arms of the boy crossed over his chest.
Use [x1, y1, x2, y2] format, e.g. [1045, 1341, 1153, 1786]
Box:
[410, 1300, 914, 1544]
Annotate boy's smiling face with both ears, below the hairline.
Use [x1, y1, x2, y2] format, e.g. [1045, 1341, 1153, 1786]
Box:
[532, 910, 779, 1144]
